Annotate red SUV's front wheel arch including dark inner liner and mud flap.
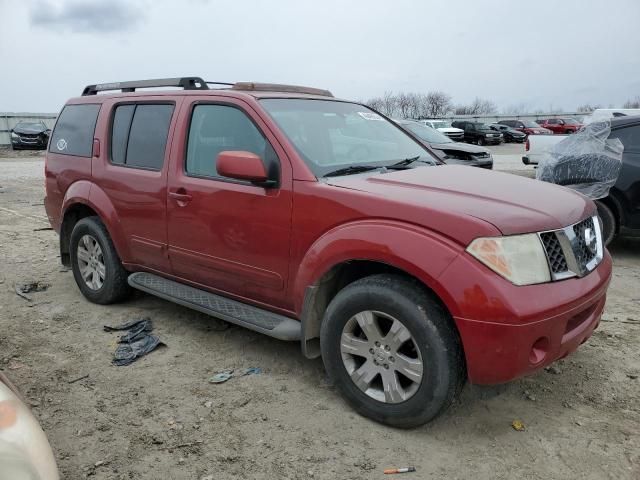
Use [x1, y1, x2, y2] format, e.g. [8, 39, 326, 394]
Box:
[294, 222, 461, 358]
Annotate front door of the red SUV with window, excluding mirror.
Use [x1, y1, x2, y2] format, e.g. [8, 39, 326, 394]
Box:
[167, 97, 292, 309]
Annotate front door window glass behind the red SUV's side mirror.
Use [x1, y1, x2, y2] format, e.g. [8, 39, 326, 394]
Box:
[186, 105, 275, 177]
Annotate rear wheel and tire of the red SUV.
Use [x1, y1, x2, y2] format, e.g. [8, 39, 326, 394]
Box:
[69, 217, 131, 305]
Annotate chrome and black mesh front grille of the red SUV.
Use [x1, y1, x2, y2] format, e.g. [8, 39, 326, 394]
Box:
[539, 217, 604, 280]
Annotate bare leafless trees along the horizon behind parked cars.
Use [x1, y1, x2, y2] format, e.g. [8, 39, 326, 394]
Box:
[364, 91, 640, 119]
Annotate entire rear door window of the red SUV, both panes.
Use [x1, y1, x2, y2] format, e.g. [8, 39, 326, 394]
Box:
[111, 104, 173, 170]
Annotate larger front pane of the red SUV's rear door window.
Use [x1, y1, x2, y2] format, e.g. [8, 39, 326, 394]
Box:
[125, 105, 173, 170]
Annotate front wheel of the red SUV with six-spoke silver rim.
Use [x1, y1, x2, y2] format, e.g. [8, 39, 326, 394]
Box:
[320, 274, 466, 428]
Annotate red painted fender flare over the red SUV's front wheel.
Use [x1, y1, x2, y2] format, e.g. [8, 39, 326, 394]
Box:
[293, 220, 464, 315]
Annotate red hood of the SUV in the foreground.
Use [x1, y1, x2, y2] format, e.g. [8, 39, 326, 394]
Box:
[326, 165, 595, 237]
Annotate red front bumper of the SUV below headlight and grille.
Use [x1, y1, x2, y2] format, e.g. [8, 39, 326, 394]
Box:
[441, 249, 612, 384]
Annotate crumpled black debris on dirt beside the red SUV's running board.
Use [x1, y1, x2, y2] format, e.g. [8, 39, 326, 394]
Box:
[104, 318, 165, 367]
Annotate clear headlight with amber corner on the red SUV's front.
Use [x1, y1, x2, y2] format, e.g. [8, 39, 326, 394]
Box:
[467, 233, 551, 285]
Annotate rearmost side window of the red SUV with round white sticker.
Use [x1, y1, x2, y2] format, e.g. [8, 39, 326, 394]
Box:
[49, 103, 100, 157]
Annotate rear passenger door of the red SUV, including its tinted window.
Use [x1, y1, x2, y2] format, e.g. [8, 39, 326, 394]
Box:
[92, 97, 178, 273]
